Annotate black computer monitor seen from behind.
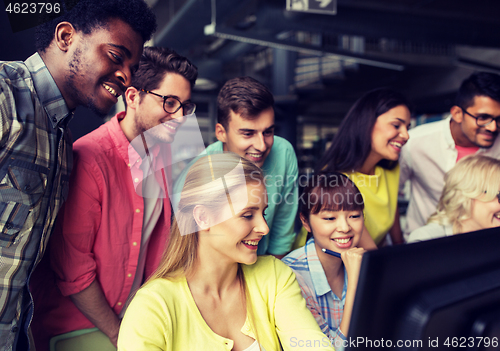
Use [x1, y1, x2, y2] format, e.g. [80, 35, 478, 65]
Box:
[345, 228, 500, 350]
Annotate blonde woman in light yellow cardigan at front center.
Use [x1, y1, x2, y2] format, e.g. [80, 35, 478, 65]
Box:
[118, 154, 333, 351]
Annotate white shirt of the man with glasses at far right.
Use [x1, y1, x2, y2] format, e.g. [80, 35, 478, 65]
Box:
[399, 116, 500, 236]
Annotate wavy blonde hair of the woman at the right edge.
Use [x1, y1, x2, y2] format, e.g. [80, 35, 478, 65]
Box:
[427, 155, 500, 234]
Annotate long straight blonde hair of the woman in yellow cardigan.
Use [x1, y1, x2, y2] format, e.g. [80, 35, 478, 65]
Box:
[149, 153, 264, 280]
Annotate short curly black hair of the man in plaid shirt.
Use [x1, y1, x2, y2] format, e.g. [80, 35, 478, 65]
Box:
[35, 0, 156, 52]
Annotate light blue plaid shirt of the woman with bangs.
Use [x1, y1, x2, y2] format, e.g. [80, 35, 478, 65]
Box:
[282, 238, 347, 350]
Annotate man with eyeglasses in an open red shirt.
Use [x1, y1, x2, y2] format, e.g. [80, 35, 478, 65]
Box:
[29, 47, 198, 351]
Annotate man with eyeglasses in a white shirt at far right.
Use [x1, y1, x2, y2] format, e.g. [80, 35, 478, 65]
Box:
[399, 72, 500, 241]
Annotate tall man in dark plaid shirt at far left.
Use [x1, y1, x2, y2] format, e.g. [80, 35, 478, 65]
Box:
[0, 0, 156, 350]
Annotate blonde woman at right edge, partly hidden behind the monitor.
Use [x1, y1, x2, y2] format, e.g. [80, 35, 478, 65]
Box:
[408, 155, 500, 242]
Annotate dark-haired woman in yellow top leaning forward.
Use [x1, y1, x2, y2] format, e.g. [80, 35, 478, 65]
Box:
[317, 89, 411, 248]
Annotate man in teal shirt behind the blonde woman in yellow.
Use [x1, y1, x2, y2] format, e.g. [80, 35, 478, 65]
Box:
[174, 77, 298, 258]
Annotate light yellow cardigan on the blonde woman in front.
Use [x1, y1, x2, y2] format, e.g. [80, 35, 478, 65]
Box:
[118, 256, 334, 351]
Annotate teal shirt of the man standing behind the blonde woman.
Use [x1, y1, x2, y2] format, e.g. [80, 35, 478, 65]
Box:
[174, 136, 298, 255]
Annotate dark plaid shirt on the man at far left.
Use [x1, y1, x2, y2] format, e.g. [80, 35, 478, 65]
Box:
[0, 53, 73, 350]
